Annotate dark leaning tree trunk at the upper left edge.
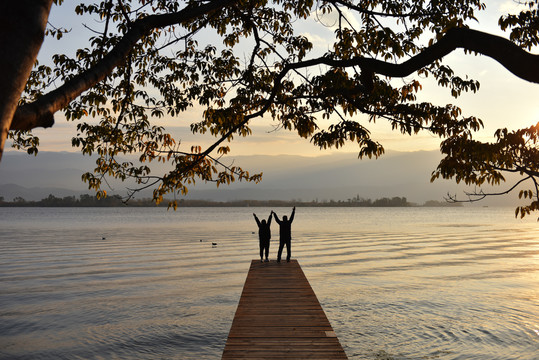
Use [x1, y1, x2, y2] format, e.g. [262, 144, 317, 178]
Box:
[0, 0, 53, 161]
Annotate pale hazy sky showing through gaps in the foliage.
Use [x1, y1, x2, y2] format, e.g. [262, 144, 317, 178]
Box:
[6, 0, 539, 156]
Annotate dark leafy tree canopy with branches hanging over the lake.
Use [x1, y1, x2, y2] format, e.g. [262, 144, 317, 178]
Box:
[3, 0, 539, 216]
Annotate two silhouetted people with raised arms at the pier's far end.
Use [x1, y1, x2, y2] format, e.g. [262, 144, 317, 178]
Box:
[253, 206, 296, 262]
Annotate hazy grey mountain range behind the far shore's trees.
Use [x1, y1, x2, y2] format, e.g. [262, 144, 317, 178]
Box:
[0, 151, 515, 205]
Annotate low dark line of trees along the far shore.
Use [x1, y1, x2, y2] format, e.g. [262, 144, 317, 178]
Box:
[0, 194, 461, 207]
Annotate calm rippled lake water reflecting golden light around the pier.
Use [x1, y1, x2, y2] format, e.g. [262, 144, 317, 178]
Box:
[0, 208, 539, 360]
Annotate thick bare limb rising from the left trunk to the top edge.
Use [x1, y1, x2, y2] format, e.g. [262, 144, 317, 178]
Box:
[10, 0, 236, 130]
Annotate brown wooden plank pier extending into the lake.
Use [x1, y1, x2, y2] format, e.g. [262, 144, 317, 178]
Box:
[222, 260, 347, 359]
